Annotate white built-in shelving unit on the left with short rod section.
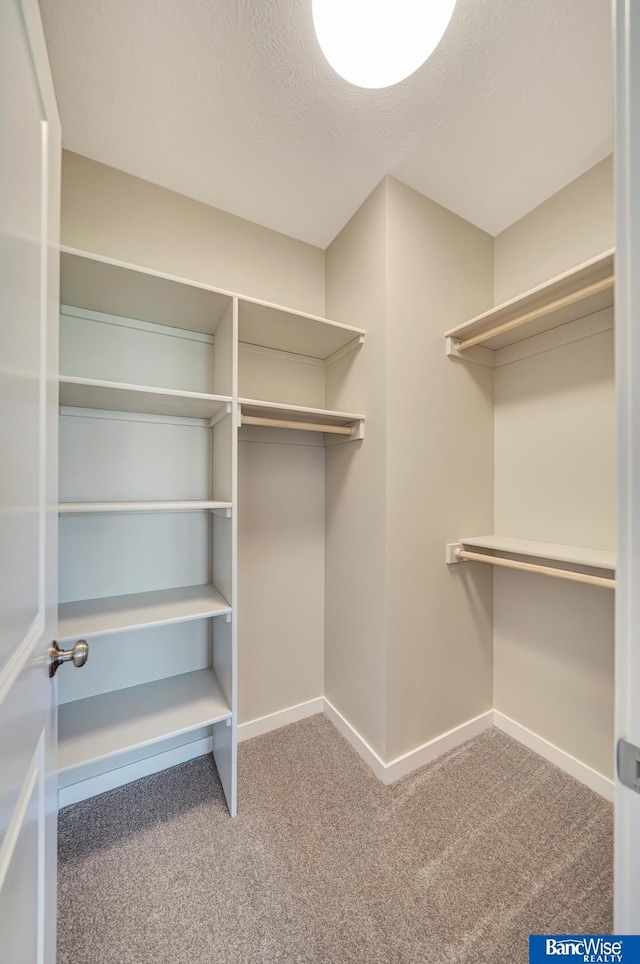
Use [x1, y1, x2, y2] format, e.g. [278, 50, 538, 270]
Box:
[58, 249, 364, 815]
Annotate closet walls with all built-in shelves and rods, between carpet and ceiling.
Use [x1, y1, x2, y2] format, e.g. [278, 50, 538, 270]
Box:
[58, 152, 615, 814]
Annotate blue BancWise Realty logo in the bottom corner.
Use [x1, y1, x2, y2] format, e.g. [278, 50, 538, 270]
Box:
[529, 934, 640, 964]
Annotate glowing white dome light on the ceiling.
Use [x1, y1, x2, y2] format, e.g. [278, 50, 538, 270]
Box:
[312, 0, 456, 88]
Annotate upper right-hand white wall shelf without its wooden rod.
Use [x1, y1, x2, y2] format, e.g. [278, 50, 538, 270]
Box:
[446, 251, 614, 358]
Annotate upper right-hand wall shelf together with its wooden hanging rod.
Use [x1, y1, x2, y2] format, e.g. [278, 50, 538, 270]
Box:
[446, 251, 614, 358]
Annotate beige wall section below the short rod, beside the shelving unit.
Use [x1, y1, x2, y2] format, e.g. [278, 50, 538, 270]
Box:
[238, 442, 324, 723]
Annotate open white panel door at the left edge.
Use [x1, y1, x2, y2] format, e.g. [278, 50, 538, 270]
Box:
[0, 0, 60, 964]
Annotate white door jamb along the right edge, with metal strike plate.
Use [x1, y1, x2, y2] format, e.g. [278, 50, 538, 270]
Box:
[614, 0, 640, 934]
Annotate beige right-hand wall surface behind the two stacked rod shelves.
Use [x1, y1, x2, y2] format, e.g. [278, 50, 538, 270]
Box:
[494, 158, 615, 776]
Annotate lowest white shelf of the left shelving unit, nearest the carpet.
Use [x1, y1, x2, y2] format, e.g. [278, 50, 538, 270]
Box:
[58, 669, 231, 771]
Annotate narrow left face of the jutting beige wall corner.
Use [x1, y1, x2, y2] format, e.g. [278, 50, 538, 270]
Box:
[325, 180, 388, 757]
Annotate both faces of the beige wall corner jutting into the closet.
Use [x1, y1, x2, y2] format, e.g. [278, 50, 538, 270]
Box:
[325, 178, 493, 761]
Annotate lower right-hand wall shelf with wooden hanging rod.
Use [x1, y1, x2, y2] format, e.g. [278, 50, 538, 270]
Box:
[446, 535, 616, 589]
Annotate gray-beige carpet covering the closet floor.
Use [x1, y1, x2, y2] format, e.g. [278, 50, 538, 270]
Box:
[58, 716, 613, 964]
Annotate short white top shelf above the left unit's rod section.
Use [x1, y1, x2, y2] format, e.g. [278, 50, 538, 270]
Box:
[238, 298, 364, 359]
